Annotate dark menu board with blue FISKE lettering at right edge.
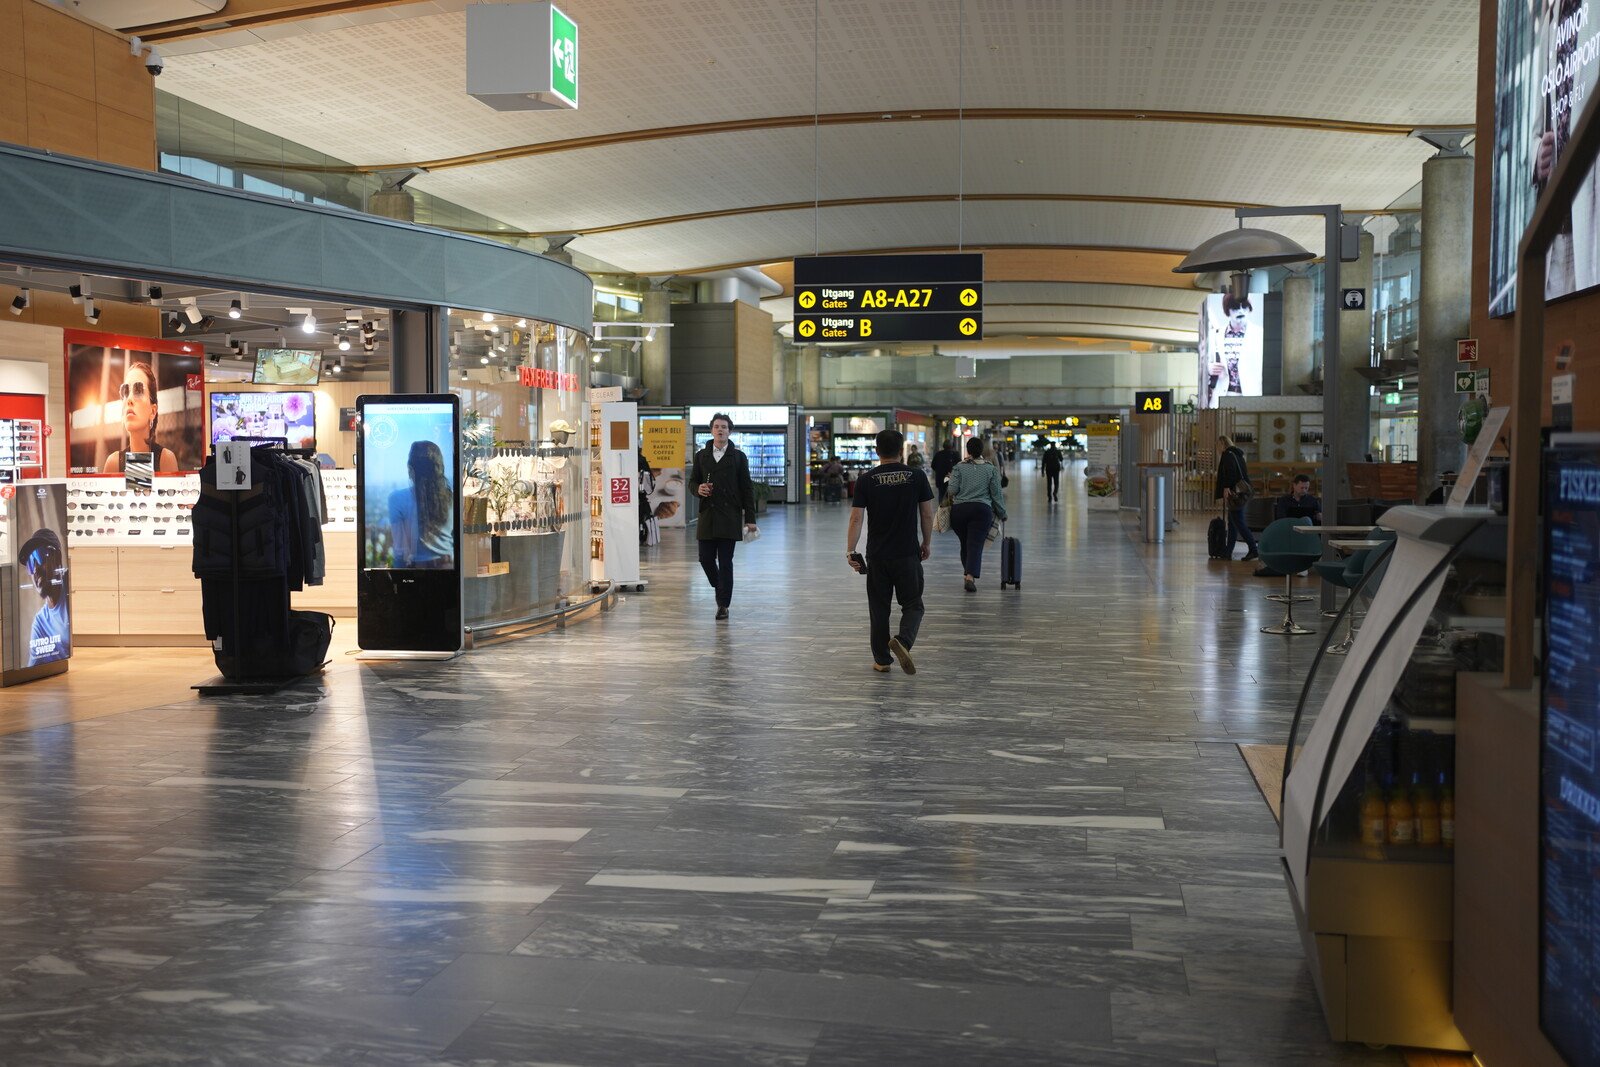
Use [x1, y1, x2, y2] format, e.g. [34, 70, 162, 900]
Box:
[1539, 435, 1600, 1064]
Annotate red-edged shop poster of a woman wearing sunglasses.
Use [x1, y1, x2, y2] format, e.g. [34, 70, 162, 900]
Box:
[66, 330, 206, 475]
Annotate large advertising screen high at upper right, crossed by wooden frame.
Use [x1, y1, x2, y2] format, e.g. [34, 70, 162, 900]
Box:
[1490, 0, 1600, 315]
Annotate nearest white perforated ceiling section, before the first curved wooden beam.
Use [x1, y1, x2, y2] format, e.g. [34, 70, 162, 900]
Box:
[162, 0, 1478, 163]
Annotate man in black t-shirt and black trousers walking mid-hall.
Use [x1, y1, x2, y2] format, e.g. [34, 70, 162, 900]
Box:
[845, 430, 933, 675]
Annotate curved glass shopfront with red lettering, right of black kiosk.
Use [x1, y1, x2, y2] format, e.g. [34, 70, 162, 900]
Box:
[450, 310, 590, 630]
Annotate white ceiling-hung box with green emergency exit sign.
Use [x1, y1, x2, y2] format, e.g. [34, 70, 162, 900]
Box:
[467, 3, 578, 110]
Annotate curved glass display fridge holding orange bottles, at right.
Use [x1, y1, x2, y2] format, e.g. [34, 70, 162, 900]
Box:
[1269, 507, 1506, 1049]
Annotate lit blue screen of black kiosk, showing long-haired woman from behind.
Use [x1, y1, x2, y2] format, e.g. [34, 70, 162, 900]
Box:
[357, 400, 459, 571]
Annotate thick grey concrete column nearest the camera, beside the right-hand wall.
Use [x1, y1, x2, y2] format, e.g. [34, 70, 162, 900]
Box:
[1416, 150, 1472, 498]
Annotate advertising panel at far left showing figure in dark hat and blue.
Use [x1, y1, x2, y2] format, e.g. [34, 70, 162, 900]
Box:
[13, 483, 72, 667]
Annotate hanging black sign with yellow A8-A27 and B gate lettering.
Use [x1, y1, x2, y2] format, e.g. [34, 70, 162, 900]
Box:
[795, 253, 984, 342]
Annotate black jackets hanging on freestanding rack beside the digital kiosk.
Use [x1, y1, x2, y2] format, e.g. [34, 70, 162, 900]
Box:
[194, 446, 331, 678]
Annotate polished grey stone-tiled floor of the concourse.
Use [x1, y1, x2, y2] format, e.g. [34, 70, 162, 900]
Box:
[0, 467, 1398, 1067]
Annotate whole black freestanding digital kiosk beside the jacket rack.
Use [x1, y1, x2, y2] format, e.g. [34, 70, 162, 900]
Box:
[355, 394, 462, 656]
